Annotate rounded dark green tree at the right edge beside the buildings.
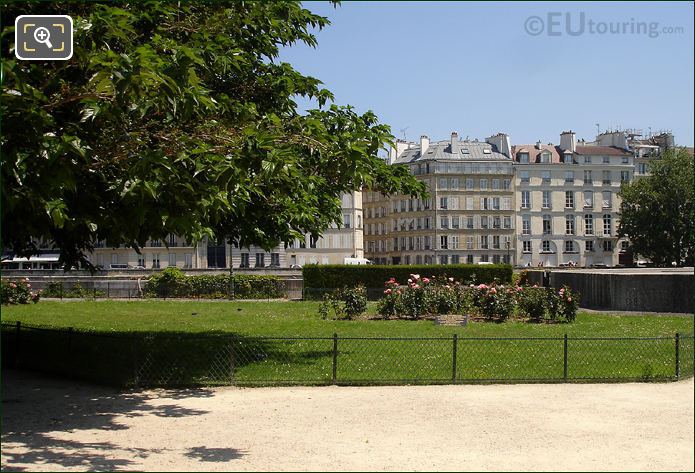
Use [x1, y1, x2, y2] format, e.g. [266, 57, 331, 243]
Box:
[618, 148, 695, 266]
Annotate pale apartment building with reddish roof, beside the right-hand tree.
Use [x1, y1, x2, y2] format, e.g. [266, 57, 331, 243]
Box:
[512, 131, 635, 266]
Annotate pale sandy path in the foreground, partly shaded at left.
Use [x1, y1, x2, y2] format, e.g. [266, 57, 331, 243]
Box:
[2, 371, 695, 471]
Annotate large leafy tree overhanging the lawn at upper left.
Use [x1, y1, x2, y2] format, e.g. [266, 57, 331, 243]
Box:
[0, 1, 426, 266]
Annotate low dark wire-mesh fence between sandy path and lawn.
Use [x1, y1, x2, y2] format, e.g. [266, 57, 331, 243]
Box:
[2, 322, 693, 386]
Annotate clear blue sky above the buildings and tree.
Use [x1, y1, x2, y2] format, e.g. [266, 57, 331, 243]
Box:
[281, 1, 695, 146]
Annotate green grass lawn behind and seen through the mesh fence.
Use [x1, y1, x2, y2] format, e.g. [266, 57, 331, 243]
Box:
[2, 300, 693, 385]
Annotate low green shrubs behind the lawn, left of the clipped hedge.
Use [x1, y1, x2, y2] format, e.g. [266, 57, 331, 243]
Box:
[145, 267, 285, 299]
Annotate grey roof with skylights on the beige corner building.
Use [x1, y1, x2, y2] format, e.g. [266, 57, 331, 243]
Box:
[396, 140, 511, 164]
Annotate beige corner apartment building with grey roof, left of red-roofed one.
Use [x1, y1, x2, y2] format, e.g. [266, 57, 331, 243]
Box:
[364, 132, 516, 264]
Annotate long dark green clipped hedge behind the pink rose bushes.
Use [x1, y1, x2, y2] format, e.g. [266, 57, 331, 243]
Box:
[302, 264, 512, 290]
